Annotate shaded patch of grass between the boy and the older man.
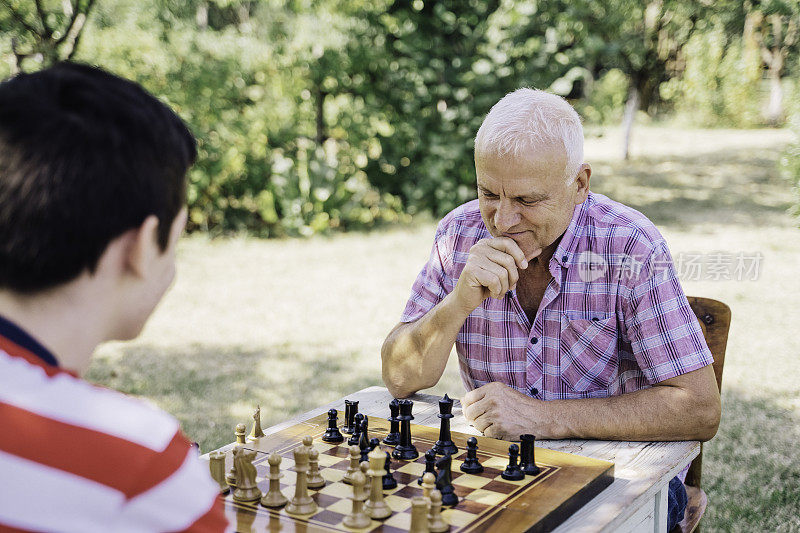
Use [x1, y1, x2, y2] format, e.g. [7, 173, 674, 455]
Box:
[87, 345, 381, 452]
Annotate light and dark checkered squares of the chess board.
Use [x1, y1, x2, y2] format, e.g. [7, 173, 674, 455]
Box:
[226, 424, 560, 533]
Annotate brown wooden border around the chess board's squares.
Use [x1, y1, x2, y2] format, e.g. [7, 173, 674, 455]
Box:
[217, 412, 614, 533]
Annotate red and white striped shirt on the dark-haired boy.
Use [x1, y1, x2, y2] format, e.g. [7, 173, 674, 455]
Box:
[0, 317, 227, 532]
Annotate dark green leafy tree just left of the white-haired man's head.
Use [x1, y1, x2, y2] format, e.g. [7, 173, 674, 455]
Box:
[331, 0, 516, 214]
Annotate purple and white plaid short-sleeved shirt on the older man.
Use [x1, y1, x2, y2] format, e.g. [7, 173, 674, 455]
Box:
[401, 193, 713, 400]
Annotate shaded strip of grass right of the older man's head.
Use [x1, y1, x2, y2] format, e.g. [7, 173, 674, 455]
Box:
[592, 148, 792, 229]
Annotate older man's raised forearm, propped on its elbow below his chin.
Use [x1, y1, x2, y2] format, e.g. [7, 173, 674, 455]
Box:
[381, 293, 469, 398]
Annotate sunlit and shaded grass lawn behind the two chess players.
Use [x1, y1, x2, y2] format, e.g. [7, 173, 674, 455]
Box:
[89, 127, 800, 531]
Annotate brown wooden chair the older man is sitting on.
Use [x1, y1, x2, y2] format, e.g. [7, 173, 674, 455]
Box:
[670, 296, 731, 533]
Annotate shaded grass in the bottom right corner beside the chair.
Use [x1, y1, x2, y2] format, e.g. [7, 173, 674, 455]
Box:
[702, 389, 800, 531]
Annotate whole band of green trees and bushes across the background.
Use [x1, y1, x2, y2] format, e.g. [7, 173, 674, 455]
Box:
[0, 0, 798, 236]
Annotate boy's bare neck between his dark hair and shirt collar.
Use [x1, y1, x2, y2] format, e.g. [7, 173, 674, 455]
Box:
[0, 289, 105, 375]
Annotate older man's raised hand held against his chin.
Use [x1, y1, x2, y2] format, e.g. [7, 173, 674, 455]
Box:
[453, 237, 541, 313]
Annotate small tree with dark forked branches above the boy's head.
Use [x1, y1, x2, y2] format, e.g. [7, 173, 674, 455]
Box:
[0, 0, 95, 72]
